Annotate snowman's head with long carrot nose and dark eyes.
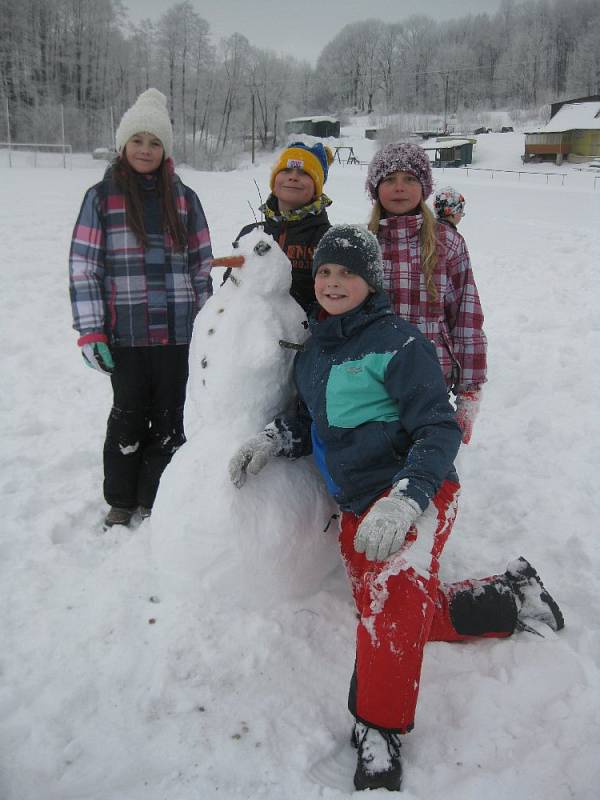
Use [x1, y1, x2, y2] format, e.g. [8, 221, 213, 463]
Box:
[213, 230, 292, 297]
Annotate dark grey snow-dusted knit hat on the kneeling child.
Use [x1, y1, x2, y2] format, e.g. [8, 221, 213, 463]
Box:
[313, 225, 383, 289]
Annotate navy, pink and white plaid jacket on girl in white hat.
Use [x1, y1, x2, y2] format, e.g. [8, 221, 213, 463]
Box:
[69, 171, 212, 347]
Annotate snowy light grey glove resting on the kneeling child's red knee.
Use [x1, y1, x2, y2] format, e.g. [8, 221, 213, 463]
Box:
[354, 489, 422, 561]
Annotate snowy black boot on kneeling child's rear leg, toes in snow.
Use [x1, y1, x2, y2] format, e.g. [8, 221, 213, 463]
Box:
[506, 556, 565, 631]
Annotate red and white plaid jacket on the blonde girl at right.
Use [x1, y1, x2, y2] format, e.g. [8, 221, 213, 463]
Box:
[378, 214, 487, 393]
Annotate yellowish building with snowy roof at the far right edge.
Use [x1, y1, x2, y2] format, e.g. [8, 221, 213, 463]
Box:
[523, 95, 600, 164]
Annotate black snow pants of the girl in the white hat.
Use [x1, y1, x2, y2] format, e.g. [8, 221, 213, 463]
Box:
[104, 345, 189, 508]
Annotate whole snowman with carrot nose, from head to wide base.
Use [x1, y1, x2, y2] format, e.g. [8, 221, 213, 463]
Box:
[150, 230, 338, 608]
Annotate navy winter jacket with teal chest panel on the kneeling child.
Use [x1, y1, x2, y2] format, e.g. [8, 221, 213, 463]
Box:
[275, 292, 461, 514]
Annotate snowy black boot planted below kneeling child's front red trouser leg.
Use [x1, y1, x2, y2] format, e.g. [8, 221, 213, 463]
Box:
[352, 722, 402, 792]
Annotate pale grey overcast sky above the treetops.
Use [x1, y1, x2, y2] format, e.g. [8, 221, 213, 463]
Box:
[124, 0, 501, 64]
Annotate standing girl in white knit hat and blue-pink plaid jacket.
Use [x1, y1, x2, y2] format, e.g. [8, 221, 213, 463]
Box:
[70, 89, 212, 526]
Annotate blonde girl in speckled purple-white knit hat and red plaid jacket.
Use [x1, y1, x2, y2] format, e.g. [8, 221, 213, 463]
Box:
[367, 143, 487, 444]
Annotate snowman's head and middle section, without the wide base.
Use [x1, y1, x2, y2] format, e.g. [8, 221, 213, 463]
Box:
[190, 231, 307, 432]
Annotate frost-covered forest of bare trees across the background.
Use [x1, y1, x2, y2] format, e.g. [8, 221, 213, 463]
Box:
[0, 0, 600, 161]
